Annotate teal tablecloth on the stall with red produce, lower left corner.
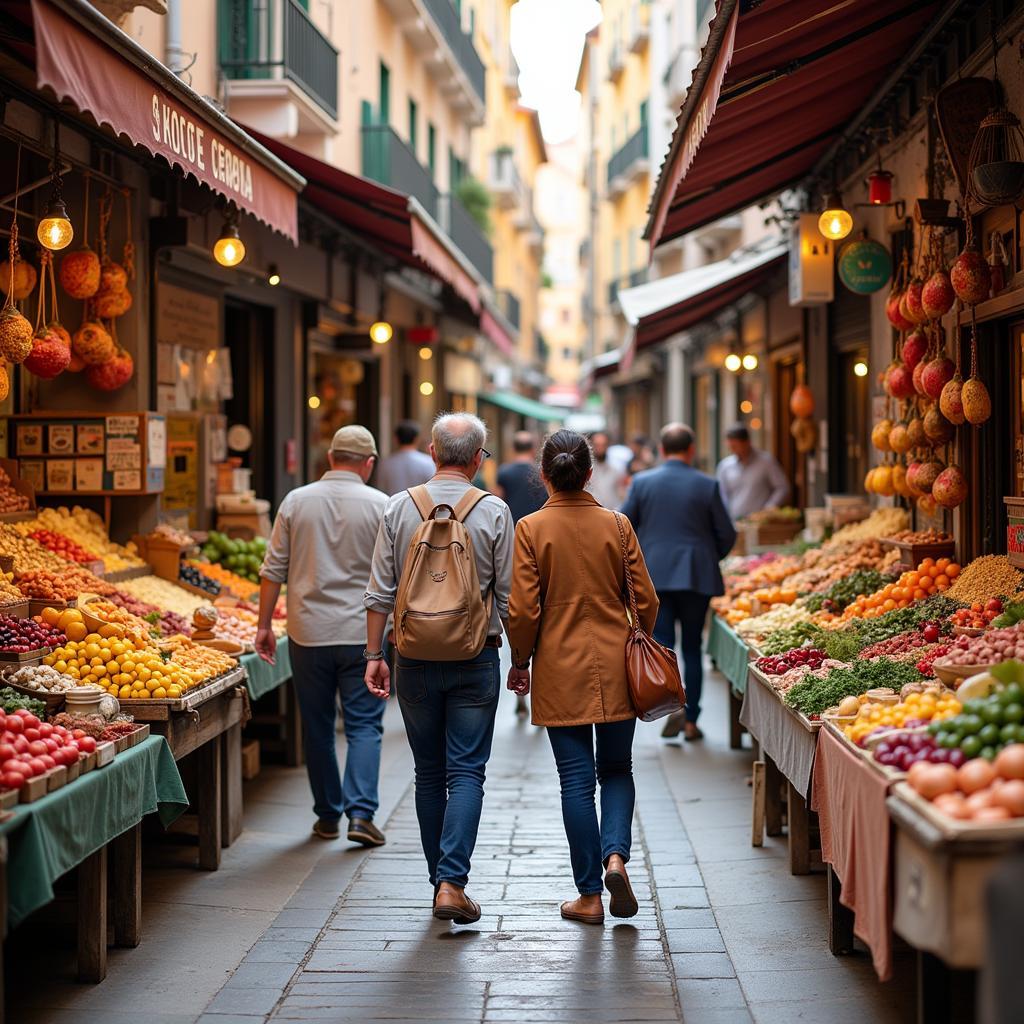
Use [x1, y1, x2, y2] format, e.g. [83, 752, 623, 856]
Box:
[0, 736, 188, 928]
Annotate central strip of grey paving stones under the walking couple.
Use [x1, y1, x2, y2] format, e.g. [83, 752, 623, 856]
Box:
[204, 692, 751, 1024]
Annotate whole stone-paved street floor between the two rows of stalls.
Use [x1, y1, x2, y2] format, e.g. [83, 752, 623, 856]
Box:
[12, 659, 912, 1024]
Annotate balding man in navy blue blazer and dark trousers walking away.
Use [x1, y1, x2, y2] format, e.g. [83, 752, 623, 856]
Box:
[622, 423, 736, 740]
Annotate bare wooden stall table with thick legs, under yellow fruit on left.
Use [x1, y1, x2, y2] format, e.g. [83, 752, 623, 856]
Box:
[126, 666, 249, 871]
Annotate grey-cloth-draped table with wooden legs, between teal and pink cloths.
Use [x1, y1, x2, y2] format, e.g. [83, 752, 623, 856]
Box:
[739, 665, 821, 874]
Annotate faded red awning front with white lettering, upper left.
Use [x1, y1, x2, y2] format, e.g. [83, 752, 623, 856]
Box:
[32, 0, 303, 243]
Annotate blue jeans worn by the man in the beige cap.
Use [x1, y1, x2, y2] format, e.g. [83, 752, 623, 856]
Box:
[289, 640, 384, 821]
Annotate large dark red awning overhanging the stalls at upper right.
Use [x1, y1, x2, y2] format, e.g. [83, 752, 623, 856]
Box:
[645, 0, 941, 248]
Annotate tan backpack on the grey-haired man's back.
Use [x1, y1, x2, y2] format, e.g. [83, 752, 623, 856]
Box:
[394, 485, 492, 662]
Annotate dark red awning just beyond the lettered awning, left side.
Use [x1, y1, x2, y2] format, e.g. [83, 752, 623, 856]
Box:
[248, 129, 480, 312]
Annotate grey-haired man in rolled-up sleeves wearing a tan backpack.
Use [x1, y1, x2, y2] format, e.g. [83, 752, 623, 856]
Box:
[364, 413, 514, 925]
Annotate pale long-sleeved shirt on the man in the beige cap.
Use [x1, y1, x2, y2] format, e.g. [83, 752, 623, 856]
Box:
[260, 469, 387, 647]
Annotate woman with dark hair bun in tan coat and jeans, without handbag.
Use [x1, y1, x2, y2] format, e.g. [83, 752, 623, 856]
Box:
[509, 430, 657, 925]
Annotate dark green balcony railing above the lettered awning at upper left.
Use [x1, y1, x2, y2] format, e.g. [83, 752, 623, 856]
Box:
[218, 0, 338, 118]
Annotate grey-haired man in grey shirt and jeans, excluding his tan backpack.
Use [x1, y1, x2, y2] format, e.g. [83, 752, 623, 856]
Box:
[364, 413, 514, 925]
